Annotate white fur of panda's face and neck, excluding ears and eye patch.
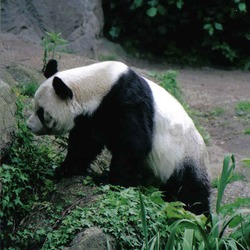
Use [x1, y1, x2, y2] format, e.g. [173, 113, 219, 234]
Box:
[27, 62, 128, 135]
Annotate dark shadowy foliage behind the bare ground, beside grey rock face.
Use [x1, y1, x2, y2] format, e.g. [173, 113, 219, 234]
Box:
[103, 0, 250, 69]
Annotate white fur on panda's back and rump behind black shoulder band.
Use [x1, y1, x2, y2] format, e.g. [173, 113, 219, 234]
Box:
[145, 79, 205, 182]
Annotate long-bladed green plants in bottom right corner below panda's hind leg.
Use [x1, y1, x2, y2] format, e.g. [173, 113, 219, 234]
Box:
[140, 155, 250, 250]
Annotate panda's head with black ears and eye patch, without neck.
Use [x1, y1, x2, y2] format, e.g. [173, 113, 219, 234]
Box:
[27, 60, 79, 135]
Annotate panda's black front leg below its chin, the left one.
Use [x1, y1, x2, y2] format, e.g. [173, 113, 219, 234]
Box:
[55, 120, 104, 179]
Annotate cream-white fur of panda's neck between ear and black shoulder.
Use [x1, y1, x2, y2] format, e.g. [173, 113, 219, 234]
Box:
[56, 62, 128, 115]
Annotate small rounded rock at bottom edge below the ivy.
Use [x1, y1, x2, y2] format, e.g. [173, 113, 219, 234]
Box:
[65, 227, 115, 250]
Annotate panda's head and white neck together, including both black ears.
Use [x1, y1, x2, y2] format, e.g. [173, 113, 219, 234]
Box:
[27, 60, 128, 135]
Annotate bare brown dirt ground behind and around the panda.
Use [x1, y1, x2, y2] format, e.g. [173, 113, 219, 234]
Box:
[0, 34, 250, 205]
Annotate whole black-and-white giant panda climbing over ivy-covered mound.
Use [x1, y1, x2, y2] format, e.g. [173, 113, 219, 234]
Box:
[27, 60, 210, 214]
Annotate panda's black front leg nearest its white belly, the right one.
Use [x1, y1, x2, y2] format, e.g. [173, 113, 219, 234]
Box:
[106, 108, 153, 187]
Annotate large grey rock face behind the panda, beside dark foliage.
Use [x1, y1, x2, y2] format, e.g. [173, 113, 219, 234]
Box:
[1, 0, 103, 56]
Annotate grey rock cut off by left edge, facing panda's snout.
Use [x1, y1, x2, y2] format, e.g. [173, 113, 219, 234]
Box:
[0, 80, 16, 162]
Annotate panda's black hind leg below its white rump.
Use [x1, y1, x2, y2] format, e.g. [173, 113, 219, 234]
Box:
[161, 161, 211, 216]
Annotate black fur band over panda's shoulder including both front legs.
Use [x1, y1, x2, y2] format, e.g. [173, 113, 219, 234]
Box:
[58, 70, 154, 186]
